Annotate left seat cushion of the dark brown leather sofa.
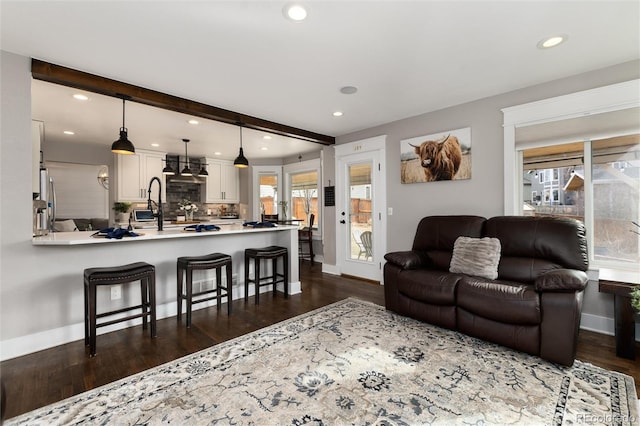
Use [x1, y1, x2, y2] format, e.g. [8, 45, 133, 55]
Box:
[398, 269, 462, 305]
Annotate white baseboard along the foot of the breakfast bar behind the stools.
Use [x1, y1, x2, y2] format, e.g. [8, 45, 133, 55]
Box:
[0, 281, 301, 361]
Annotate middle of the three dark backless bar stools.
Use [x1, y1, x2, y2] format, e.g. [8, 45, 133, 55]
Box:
[178, 253, 232, 328]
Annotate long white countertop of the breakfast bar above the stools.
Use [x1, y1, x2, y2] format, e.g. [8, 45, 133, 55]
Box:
[32, 224, 298, 246]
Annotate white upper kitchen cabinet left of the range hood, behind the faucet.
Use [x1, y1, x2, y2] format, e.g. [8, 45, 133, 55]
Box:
[115, 149, 167, 202]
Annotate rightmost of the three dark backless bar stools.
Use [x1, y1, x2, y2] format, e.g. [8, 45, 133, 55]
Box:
[244, 246, 289, 305]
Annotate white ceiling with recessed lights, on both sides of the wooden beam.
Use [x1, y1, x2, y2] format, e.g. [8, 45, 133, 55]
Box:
[0, 0, 640, 160]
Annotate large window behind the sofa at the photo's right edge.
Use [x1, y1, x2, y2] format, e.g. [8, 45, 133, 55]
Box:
[521, 134, 640, 269]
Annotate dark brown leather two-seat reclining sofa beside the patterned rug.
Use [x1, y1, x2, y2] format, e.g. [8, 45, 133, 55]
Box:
[384, 216, 588, 365]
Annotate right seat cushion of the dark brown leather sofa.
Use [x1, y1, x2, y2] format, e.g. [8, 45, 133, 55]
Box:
[457, 276, 541, 325]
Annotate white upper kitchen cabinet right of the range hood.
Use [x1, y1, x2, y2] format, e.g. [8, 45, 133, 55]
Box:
[204, 158, 240, 203]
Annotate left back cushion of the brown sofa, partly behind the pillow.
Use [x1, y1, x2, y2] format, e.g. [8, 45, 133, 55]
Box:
[412, 216, 486, 271]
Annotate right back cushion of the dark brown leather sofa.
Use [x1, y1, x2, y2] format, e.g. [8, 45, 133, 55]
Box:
[484, 216, 589, 283]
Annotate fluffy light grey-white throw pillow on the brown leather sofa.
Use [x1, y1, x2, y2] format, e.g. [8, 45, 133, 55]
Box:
[449, 237, 500, 280]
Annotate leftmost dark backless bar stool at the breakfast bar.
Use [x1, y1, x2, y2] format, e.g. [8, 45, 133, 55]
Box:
[84, 262, 156, 357]
